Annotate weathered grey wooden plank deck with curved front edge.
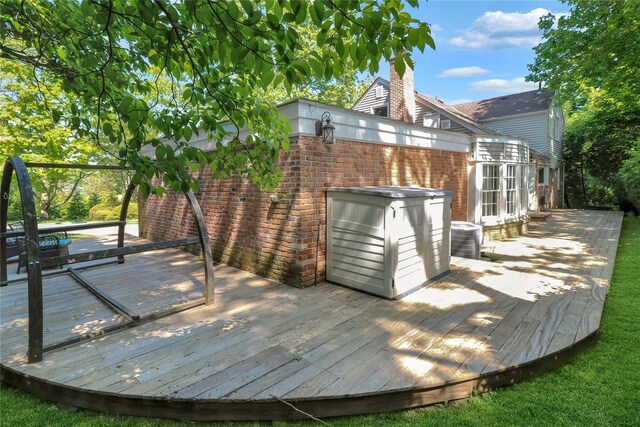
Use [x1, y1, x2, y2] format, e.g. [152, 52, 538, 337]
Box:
[0, 211, 622, 420]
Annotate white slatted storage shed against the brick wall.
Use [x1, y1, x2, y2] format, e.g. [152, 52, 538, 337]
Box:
[327, 187, 451, 298]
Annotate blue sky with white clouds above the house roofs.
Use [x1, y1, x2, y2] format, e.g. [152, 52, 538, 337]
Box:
[379, 0, 569, 103]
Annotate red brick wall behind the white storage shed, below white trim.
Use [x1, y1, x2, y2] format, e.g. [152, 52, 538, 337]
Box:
[140, 136, 467, 287]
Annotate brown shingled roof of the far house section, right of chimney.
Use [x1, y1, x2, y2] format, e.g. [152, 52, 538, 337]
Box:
[455, 90, 553, 121]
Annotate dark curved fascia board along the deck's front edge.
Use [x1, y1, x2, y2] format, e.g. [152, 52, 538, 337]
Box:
[0, 329, 599, 421]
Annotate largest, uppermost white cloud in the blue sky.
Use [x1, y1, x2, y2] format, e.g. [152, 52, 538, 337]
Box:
[450, 8, 550, 49]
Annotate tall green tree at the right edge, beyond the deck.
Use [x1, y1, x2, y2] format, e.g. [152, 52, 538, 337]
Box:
[528, 0, 640, 208]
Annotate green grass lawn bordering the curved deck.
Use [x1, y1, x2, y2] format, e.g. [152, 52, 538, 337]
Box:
[0, 218, 640, 427]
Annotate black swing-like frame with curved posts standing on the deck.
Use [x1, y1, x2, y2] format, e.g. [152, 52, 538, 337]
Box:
[0, 157, 214, 363]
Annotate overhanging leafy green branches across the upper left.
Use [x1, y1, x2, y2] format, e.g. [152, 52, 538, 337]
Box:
[0, 0, 433, 194]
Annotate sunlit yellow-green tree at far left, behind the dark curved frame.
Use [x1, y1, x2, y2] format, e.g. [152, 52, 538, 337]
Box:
[0, 59, 104, 218]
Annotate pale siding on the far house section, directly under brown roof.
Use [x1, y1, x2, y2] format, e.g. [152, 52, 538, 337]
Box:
[482, 111, 551, 155]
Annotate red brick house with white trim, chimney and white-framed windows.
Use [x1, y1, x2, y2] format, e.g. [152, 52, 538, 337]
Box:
[140, 62, 540, 287]
